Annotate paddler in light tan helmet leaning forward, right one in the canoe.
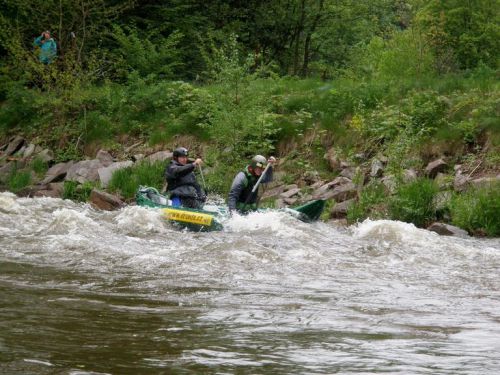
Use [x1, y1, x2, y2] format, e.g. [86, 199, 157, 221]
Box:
[228, 155, 276, 213]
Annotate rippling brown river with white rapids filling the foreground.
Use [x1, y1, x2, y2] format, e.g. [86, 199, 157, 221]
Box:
[0, 193, 500, 375]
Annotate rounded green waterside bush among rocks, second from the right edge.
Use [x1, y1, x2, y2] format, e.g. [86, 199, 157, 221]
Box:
[389, 178, 439, 227]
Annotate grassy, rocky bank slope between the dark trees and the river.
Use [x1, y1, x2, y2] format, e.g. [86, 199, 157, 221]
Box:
[0, 69, 500, 236]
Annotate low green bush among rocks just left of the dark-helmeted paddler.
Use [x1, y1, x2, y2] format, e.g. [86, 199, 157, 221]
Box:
[108, 161, 166, 203]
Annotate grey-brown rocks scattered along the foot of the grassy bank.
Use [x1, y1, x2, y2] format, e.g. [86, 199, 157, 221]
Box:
[0, 136, 500, 236]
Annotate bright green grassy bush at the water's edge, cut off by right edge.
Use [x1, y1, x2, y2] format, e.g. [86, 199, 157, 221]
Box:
[450, 183, 500, 236]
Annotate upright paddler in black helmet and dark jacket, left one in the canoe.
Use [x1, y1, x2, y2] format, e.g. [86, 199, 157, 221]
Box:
[165, 147, 207, 208]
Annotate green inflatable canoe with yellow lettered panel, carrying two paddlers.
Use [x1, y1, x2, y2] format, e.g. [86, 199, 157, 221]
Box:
[135, 186, 325, 231]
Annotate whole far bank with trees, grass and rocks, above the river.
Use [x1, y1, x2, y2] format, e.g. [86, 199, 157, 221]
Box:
[0, 0, 500, 237]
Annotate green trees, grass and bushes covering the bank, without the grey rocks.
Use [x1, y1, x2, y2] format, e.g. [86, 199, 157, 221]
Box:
[0, 0, 500, 232]
